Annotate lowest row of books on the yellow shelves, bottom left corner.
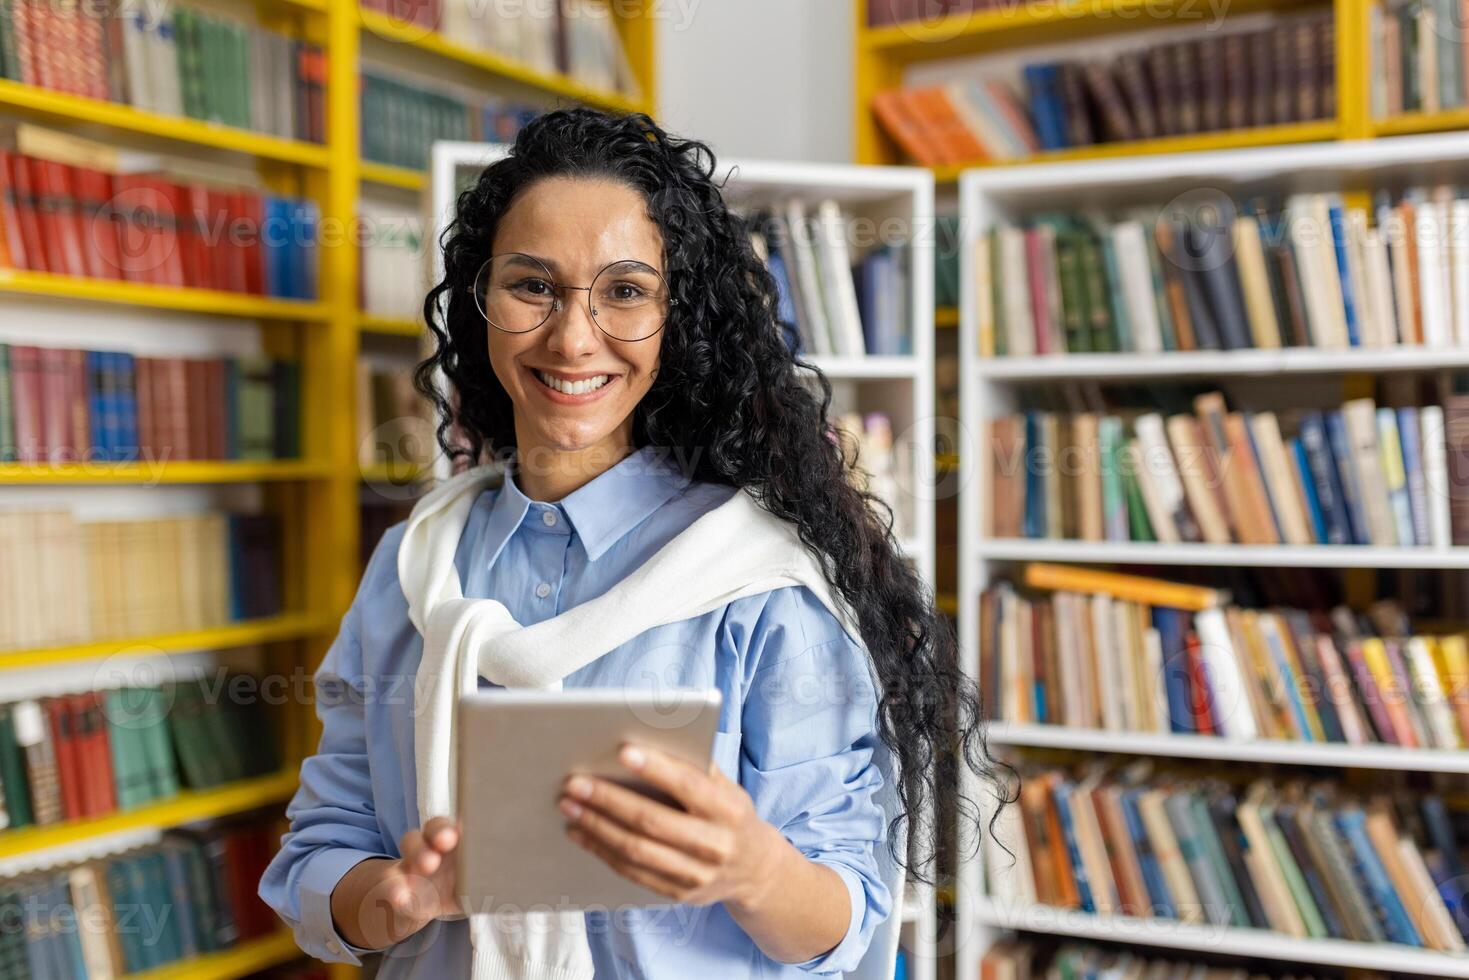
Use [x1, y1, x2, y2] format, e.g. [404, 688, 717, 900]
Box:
[0, 817, 279, 980]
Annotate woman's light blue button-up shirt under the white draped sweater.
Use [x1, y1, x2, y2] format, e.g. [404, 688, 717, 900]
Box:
[260, 448, 893, 980]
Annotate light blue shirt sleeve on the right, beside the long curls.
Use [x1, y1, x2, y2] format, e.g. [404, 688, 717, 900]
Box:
[727, 586, 893, 974]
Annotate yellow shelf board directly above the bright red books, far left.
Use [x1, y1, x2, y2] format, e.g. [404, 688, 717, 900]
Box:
[0, 78, 328, 169]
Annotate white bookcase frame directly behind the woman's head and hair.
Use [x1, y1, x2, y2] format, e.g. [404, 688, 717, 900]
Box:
[425, 141, 937, 980]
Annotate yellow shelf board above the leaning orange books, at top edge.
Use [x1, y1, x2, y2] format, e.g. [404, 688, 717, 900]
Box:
[858, 0, 1310, 63]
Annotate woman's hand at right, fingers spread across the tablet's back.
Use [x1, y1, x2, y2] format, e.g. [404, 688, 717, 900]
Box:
[558, 745, 851, 962]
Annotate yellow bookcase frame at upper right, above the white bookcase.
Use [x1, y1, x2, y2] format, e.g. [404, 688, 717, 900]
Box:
[852, 0, 1380, 182]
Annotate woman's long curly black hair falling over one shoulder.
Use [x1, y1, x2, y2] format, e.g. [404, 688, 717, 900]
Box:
[416, 109, 1006, 880]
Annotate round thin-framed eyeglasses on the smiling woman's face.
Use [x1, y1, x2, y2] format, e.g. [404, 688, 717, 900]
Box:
[473, 251, 676, 341]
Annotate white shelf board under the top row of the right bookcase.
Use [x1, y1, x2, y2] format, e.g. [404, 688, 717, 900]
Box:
[974, 347, 1469, 381]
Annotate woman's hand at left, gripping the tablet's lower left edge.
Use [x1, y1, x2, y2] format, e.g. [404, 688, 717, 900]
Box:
[332, 817, 460, 949]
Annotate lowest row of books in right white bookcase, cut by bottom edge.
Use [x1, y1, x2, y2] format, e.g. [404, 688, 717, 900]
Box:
[980, 939, 1388, 980]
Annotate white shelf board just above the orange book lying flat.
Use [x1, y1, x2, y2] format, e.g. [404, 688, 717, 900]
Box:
[975, 538, 1469, 569]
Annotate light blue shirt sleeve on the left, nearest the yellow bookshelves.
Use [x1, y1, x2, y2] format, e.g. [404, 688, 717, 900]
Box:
[259, 549, 397, 965]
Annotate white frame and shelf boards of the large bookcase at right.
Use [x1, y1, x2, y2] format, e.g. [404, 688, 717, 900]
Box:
[955, 134, 1469, 977]
